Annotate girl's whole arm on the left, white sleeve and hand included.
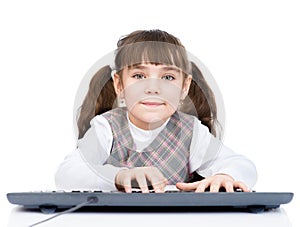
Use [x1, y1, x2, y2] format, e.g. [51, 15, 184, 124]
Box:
[55, 116, 167, 192]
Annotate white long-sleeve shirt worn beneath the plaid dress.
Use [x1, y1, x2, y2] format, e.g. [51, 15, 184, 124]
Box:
[55, 115, 257, 191]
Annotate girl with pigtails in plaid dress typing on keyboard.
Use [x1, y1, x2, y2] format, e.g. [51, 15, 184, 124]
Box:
[55, 30, 256, 193]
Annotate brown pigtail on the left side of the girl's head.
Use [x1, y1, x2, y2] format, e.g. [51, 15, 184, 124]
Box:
[77, 65, 116, 139]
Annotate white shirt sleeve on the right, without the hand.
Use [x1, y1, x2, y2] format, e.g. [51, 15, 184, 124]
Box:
[190, 119, 257, 188]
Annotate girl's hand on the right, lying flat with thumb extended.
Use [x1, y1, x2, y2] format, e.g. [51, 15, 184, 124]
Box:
[176, 174, 250, 192]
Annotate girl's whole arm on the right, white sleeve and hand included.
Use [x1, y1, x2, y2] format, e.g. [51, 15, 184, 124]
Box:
[178, 120, 257, 191]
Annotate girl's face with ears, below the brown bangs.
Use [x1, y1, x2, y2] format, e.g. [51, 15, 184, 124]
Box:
[114, 63, 191, 130]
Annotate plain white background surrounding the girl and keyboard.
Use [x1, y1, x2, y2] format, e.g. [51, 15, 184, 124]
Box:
[0, 0, 300, 226]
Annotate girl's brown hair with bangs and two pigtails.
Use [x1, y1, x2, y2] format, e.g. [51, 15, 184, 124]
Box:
[77, 30, 217, 139]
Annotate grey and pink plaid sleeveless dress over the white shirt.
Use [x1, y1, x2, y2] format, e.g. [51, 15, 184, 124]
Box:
[103, 108, 194, 184]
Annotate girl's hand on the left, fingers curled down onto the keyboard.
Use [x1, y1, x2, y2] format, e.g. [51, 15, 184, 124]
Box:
[115, 167, 168, 193]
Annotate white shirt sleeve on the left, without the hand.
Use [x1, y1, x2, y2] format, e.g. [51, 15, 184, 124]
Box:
[55, 116, 123, 191]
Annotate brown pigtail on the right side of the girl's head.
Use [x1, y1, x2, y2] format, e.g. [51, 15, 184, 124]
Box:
[184, 62, 218, 136]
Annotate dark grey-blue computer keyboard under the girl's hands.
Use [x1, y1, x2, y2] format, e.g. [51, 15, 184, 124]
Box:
[7, 188, 293, 213]
